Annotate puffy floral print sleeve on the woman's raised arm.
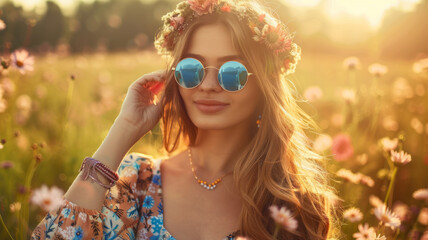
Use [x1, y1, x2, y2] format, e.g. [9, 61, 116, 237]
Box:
[31, 153, 153, 239]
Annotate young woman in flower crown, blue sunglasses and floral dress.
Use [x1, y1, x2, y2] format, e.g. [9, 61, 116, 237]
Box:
[32, 0, 334, 240]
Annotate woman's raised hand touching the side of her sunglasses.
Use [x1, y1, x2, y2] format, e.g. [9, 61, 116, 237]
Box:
[116, 70, 166, 140]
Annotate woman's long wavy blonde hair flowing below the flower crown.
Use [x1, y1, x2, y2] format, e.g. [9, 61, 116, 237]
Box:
[161, 3, 335, 240]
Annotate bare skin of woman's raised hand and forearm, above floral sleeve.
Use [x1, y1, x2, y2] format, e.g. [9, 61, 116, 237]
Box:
[65, 70, 165, 210]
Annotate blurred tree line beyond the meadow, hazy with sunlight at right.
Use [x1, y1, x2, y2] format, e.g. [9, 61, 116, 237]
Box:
[0, 0, 428, 58]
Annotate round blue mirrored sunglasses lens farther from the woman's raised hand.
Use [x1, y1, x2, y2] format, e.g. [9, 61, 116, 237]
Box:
[218, 61, 248, 91]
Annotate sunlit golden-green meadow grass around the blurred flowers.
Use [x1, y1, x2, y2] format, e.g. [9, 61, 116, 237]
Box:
[0, 51, 428, 239]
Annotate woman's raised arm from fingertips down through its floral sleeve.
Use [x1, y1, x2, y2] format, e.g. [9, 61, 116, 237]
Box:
[31, 70, 165, 239]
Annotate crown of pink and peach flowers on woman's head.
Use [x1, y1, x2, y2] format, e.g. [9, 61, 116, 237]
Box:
[154, 0, 300, 74]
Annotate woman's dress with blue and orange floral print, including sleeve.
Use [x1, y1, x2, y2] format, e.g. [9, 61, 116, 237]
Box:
[31, 153, 239, 240]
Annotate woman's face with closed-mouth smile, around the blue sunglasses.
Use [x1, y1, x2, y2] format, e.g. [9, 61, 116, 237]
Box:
[179, 24, 262, 130]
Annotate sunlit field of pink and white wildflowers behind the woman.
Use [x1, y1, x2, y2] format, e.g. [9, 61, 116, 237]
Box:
[0, 49, 428, 239]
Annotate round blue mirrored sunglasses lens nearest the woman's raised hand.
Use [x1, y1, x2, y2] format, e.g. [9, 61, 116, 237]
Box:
[175, 58, 204, 88]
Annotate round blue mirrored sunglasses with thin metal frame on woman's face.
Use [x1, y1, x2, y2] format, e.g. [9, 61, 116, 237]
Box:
[172, 58, 253, 92]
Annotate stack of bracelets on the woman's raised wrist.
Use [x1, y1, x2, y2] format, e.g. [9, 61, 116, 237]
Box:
[79, 157, 119, 190]
